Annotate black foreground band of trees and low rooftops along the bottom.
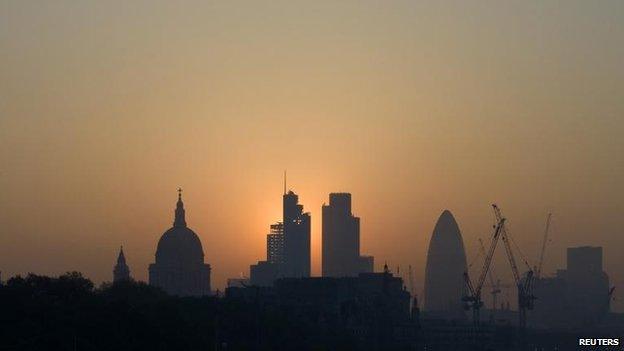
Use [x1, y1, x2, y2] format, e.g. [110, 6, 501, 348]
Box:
[0, 273, 622, 351]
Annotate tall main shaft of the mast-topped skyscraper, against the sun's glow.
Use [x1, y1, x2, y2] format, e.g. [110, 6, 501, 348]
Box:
[280, 191, 310, 277]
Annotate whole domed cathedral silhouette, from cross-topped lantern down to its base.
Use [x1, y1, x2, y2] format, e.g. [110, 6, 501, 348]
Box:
[149, 189, 210, 296]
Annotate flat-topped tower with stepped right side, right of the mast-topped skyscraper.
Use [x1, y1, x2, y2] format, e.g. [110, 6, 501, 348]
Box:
[322, 193, 373, 277]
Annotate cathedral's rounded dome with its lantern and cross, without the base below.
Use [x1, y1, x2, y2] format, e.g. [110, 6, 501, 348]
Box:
[156, 194, 204, 266]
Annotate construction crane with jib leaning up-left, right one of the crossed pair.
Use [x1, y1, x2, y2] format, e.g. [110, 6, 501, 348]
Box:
[492, 204, 535, 334]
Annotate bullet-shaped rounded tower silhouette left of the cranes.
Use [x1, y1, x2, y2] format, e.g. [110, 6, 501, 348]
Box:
[424, 210, 467, 318]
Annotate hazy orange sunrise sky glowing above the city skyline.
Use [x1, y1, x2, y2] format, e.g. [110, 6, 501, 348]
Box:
[0, 0, 624, 310]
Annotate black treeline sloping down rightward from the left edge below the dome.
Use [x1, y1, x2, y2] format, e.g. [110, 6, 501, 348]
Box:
[0, 272, 353, 351]
